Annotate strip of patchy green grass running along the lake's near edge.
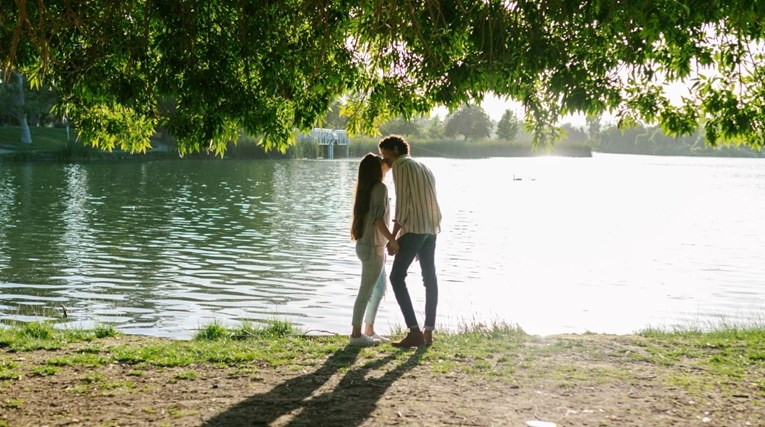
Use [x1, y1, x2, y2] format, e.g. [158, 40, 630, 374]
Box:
[0, 320, 765, 408]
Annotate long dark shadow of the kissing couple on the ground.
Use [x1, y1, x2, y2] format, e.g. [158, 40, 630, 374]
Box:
[203, 346, 426, 427]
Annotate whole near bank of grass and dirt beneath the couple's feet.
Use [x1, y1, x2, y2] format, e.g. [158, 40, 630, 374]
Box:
[0, 322, 765, 426]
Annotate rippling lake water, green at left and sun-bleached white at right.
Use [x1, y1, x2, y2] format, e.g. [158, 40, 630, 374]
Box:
[0, 155, 765, 338]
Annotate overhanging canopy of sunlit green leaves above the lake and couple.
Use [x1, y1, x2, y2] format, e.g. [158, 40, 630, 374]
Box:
[0, 0, 765, 154]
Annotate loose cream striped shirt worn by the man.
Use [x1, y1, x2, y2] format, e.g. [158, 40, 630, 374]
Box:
[392, 154, 441, 234]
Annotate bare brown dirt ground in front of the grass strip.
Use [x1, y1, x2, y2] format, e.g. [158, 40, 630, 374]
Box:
[0, 336, 765, 426]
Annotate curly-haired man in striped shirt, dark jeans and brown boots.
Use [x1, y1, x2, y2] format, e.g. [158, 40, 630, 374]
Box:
[379, 135, 441, 347]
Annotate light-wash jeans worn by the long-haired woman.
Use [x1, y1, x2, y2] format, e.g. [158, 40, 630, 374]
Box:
[351, 243, 385, 328]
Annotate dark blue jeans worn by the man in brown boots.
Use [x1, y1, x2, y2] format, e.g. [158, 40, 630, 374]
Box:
[390, 233, 438, 331]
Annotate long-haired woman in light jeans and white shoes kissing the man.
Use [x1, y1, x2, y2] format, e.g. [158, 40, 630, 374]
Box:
[351, 153, 398, 346]
